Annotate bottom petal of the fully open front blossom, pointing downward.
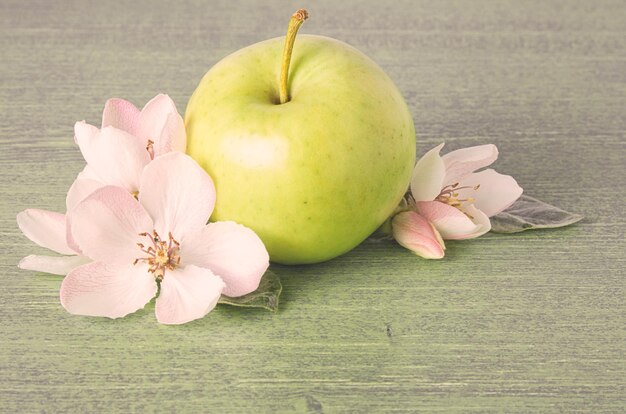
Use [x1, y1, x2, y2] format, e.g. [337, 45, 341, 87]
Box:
[155, 266, 224, 325]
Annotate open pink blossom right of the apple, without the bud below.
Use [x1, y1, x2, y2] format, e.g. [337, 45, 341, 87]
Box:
[400, 144, 523, 240]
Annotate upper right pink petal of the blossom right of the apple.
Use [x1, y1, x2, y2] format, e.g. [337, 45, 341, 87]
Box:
[442, 144, 498, 185]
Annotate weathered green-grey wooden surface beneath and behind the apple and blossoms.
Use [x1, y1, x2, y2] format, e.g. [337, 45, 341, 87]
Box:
[0, 0, 626, 413]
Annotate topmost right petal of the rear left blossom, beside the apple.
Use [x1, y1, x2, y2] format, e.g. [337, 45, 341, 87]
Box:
[136, 94, 187, 156]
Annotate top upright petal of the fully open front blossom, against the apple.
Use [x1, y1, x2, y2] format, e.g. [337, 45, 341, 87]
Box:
[139, 152, 215, 241]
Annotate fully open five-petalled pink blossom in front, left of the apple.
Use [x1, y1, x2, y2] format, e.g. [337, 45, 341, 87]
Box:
[60, 152, 269, 324]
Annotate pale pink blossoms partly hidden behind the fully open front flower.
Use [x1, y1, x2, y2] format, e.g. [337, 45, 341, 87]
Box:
[17, 94, 186, 275]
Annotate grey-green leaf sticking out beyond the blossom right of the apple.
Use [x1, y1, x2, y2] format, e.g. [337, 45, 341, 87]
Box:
[490, 195, 583, 233]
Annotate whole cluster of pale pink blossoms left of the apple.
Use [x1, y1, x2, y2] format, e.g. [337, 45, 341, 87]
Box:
[17, 95, 269, 324]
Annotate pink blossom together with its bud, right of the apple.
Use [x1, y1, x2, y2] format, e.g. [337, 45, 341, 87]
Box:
[392, 144, 523, 259]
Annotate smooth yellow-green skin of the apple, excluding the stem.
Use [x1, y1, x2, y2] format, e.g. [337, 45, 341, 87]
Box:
[185, 35, 415, 264]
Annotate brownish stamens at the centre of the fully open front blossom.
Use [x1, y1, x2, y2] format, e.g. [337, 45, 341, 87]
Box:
[133, 230, 180, 281]
